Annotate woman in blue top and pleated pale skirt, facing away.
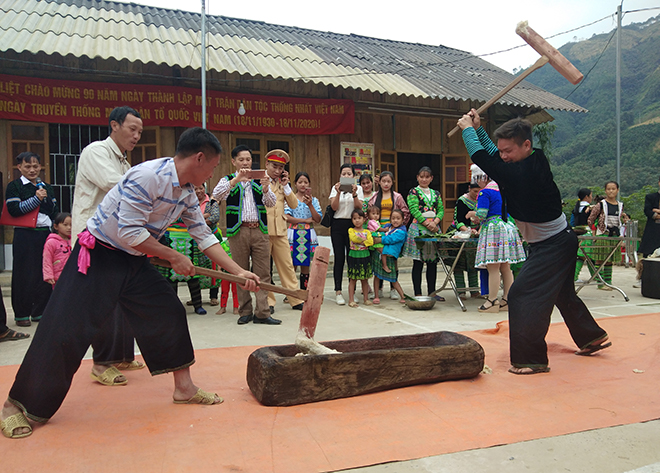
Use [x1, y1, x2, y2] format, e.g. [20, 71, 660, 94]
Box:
[467, 166, 526, 312]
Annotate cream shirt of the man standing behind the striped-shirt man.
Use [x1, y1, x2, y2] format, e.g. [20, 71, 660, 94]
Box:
[71, 137, 131, 245]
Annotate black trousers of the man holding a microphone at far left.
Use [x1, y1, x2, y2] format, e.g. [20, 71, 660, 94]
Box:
[11, 227, 53, 322]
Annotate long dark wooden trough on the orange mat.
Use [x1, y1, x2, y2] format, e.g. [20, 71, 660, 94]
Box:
[247, 332, 484, 406]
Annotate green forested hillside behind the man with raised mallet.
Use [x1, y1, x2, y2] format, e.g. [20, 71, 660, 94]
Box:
[527, 15, 660, 197]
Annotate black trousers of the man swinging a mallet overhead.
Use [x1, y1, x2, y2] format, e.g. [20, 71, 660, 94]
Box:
[509, 228, 605, 368]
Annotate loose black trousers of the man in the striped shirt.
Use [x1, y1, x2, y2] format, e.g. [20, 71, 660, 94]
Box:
[9, 241, 195, 422]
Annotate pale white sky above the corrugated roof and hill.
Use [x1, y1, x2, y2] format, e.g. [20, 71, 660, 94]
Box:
[113, 0, 660, 72]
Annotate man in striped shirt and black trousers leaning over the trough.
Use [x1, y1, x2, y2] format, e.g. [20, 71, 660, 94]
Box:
[0, 128, 260, 438]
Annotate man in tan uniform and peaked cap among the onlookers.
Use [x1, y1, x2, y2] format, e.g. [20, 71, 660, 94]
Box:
[266, 149, 303, 313]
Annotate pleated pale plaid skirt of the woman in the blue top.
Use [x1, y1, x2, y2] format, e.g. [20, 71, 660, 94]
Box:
[474, 215, 527, 269]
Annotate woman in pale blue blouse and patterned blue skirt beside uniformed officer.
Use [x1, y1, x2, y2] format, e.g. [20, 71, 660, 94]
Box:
[284, 172, 322, 289]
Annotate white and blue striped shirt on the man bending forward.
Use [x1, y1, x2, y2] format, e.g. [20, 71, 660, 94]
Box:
[87, 158, 218, 256]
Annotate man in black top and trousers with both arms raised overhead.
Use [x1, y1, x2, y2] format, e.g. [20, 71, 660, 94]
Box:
[458, 109, 611, 374]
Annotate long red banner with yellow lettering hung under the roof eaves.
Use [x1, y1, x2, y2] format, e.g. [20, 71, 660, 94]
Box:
[0, 74, 355, 135]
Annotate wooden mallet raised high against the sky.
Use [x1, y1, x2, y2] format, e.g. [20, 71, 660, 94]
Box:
[447, 21, 584, 137]
